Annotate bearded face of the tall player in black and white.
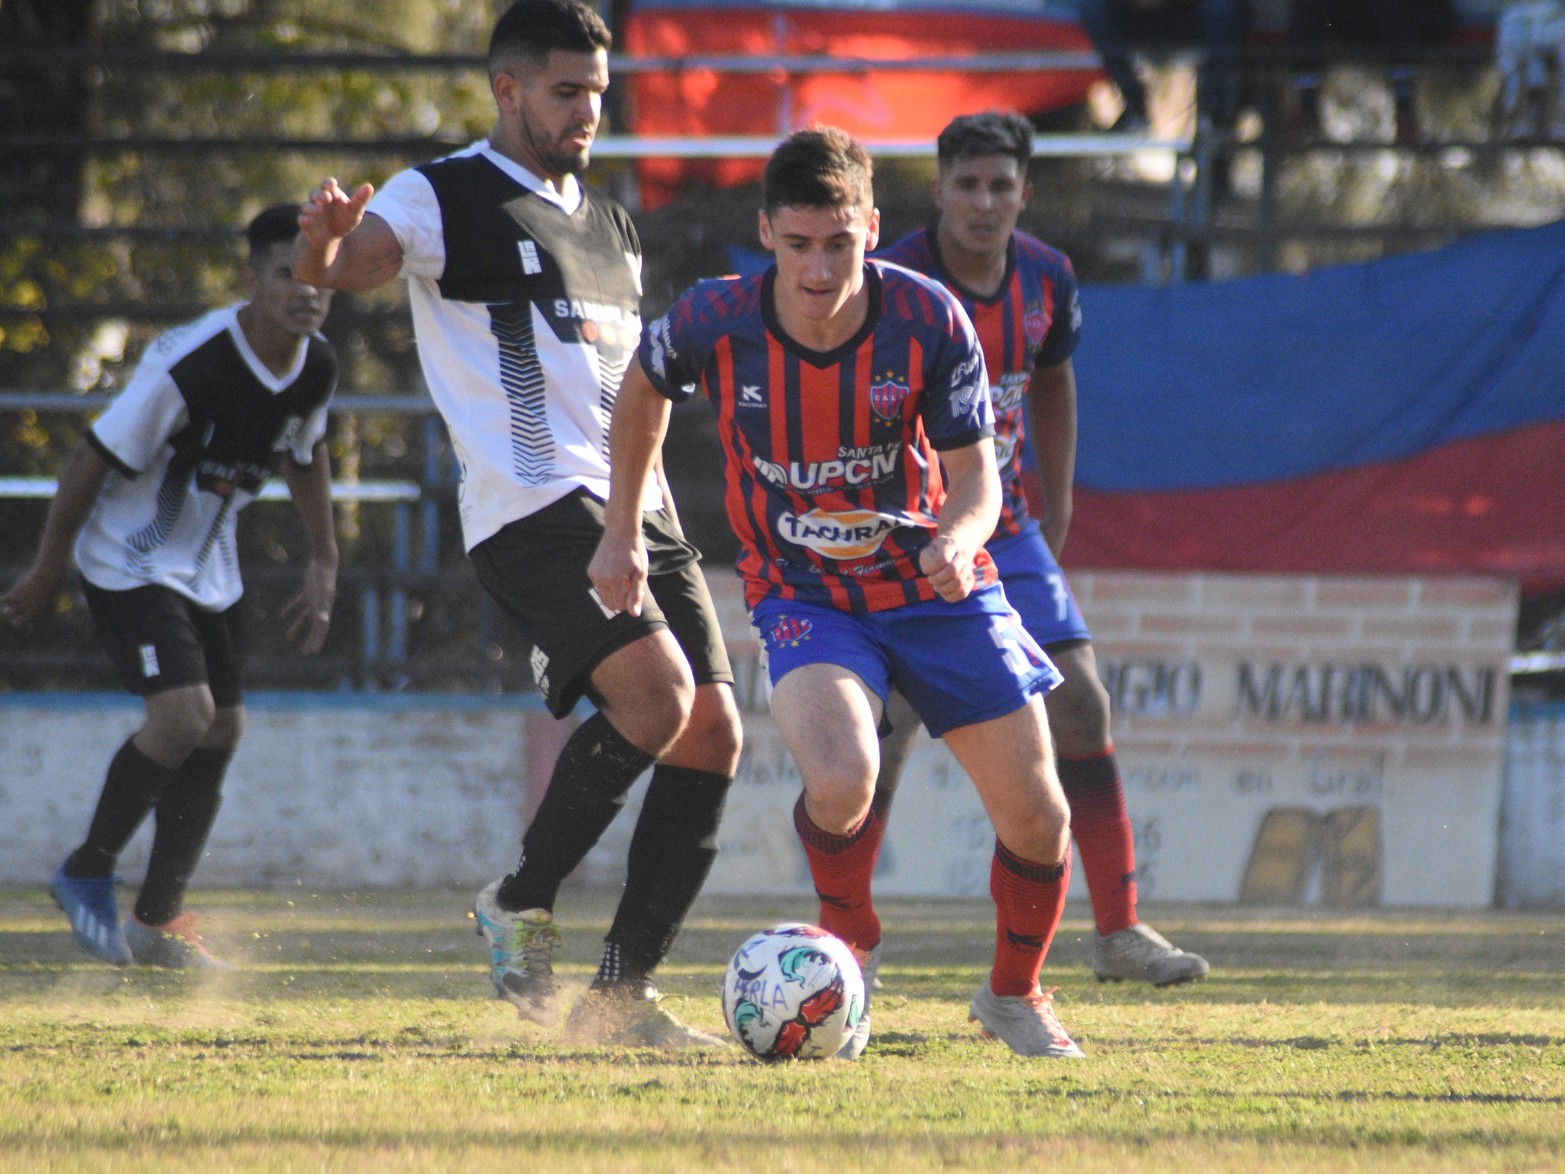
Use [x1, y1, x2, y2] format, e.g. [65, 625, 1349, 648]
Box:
[495, 49, 609, 180]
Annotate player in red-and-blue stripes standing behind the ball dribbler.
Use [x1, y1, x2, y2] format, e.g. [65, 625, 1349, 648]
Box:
[875, 113, 1207, 986]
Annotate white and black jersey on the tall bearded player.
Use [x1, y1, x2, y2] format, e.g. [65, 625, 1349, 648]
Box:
[369, 142, 660, 549]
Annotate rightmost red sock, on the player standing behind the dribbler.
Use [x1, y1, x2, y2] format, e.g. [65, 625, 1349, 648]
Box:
[1058, 747, 1136, 935]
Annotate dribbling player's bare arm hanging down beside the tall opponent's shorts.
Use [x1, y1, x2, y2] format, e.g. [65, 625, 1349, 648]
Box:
[587, 358, 670, 615]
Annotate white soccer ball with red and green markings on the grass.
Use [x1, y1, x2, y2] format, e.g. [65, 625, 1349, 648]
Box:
[723, 922, 864, 1061]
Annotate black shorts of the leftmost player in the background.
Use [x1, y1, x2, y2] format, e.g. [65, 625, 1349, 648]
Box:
[81, 582, 246, 706]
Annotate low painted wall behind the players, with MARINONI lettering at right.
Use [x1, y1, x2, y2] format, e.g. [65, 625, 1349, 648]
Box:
[0, 573, 1539, 906]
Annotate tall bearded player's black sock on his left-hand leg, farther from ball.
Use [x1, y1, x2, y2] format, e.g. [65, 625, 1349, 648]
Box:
[496, 714, 654, 911]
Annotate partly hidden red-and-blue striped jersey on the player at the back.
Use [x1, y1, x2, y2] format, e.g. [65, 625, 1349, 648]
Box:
[876, 227, 1081, 534]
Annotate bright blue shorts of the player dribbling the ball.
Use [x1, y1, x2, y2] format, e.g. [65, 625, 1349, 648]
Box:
[751, 584, 1063, 737]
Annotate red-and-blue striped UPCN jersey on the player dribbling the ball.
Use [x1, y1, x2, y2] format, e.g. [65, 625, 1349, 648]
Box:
[640, 261, 994, 612]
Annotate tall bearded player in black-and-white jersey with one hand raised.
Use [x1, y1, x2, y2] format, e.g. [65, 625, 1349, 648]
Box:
[294, 0, 740, 1047]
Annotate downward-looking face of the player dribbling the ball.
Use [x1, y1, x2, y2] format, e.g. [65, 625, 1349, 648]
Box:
[761, 207, 880, 322]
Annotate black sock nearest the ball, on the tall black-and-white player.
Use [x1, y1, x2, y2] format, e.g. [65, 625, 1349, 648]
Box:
[595, 764, 734, 985]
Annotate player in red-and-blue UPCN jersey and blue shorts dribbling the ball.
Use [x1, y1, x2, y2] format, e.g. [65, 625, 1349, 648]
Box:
[590, 128, 1081, 1058]
